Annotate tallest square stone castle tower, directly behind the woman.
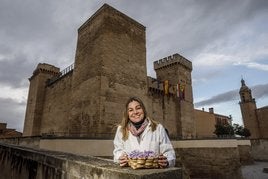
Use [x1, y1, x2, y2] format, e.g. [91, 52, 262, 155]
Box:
[69, 5, 147, 136]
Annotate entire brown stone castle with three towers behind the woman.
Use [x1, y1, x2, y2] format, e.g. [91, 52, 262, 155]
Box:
[23, 4, 195, 138]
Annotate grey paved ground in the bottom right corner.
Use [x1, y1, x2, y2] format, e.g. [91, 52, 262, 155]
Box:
[242, 162, 268, 179]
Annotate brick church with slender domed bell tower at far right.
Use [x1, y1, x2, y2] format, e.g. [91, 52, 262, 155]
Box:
[239, 79, 268, 139]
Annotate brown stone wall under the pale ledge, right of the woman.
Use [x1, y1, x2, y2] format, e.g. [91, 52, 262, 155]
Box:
[176, 148, 242, 179]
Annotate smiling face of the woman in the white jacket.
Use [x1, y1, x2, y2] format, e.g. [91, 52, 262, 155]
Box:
[127, 101, 144, 123]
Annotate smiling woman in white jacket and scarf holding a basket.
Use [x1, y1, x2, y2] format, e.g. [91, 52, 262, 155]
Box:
[113, 97, 176, 168]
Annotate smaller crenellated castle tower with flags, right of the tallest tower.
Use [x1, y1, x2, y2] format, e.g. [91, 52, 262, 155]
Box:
[149, 54, 196, 138]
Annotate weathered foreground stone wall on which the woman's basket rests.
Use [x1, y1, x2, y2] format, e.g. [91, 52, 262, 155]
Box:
[0, 143, 182, 179]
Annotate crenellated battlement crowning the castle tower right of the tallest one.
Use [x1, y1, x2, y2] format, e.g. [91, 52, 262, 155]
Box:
[154, 53, 193, 71]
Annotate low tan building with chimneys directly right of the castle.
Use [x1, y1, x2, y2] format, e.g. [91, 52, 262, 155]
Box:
[194, 108, 232, 138]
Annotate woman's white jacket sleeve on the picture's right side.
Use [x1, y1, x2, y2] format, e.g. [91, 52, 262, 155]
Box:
[159, 124, 176, 167]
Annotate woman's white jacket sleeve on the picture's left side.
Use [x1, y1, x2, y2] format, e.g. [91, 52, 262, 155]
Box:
[113, 126, 126, 163]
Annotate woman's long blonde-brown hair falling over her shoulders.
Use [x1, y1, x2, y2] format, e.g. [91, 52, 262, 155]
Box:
[120, 97, 158, 141]
